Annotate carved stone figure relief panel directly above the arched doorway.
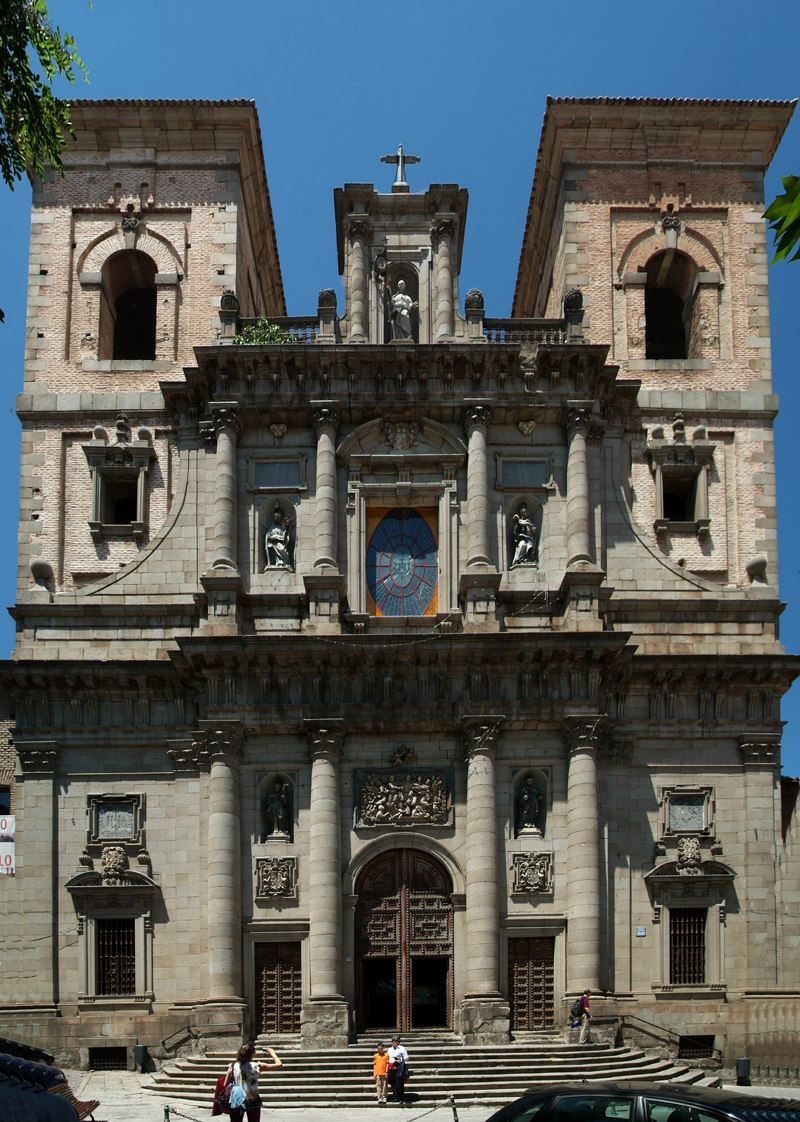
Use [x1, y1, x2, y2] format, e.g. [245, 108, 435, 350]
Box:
[358, 771, 451, 826]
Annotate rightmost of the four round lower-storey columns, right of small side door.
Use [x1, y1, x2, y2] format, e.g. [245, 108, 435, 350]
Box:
[563, 717, 604, 993]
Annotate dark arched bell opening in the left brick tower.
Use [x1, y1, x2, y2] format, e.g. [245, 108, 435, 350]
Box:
[100, 249, 158, 361]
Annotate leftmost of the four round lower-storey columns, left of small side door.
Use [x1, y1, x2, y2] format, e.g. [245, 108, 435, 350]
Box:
[200, 725, 245, 1002]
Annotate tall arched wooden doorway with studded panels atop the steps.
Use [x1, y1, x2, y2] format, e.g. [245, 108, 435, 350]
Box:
[356, 849, 453, 1031]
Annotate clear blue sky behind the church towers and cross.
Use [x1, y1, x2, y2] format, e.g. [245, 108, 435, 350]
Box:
[0, 0, 800, 774]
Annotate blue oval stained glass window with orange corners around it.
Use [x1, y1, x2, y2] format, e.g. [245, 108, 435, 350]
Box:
[367, 509, 439, 616]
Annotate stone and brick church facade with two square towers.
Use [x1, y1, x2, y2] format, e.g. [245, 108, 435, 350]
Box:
[0, 99, 800, 1065]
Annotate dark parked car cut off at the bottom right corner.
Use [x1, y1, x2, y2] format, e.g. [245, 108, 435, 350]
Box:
[487, 1082, 800, 1122]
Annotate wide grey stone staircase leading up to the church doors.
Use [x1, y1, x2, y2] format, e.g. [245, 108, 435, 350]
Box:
[146, 1032, 719, 1110]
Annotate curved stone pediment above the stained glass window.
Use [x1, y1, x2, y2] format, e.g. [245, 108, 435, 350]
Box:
[337, 416, 467, 468]
